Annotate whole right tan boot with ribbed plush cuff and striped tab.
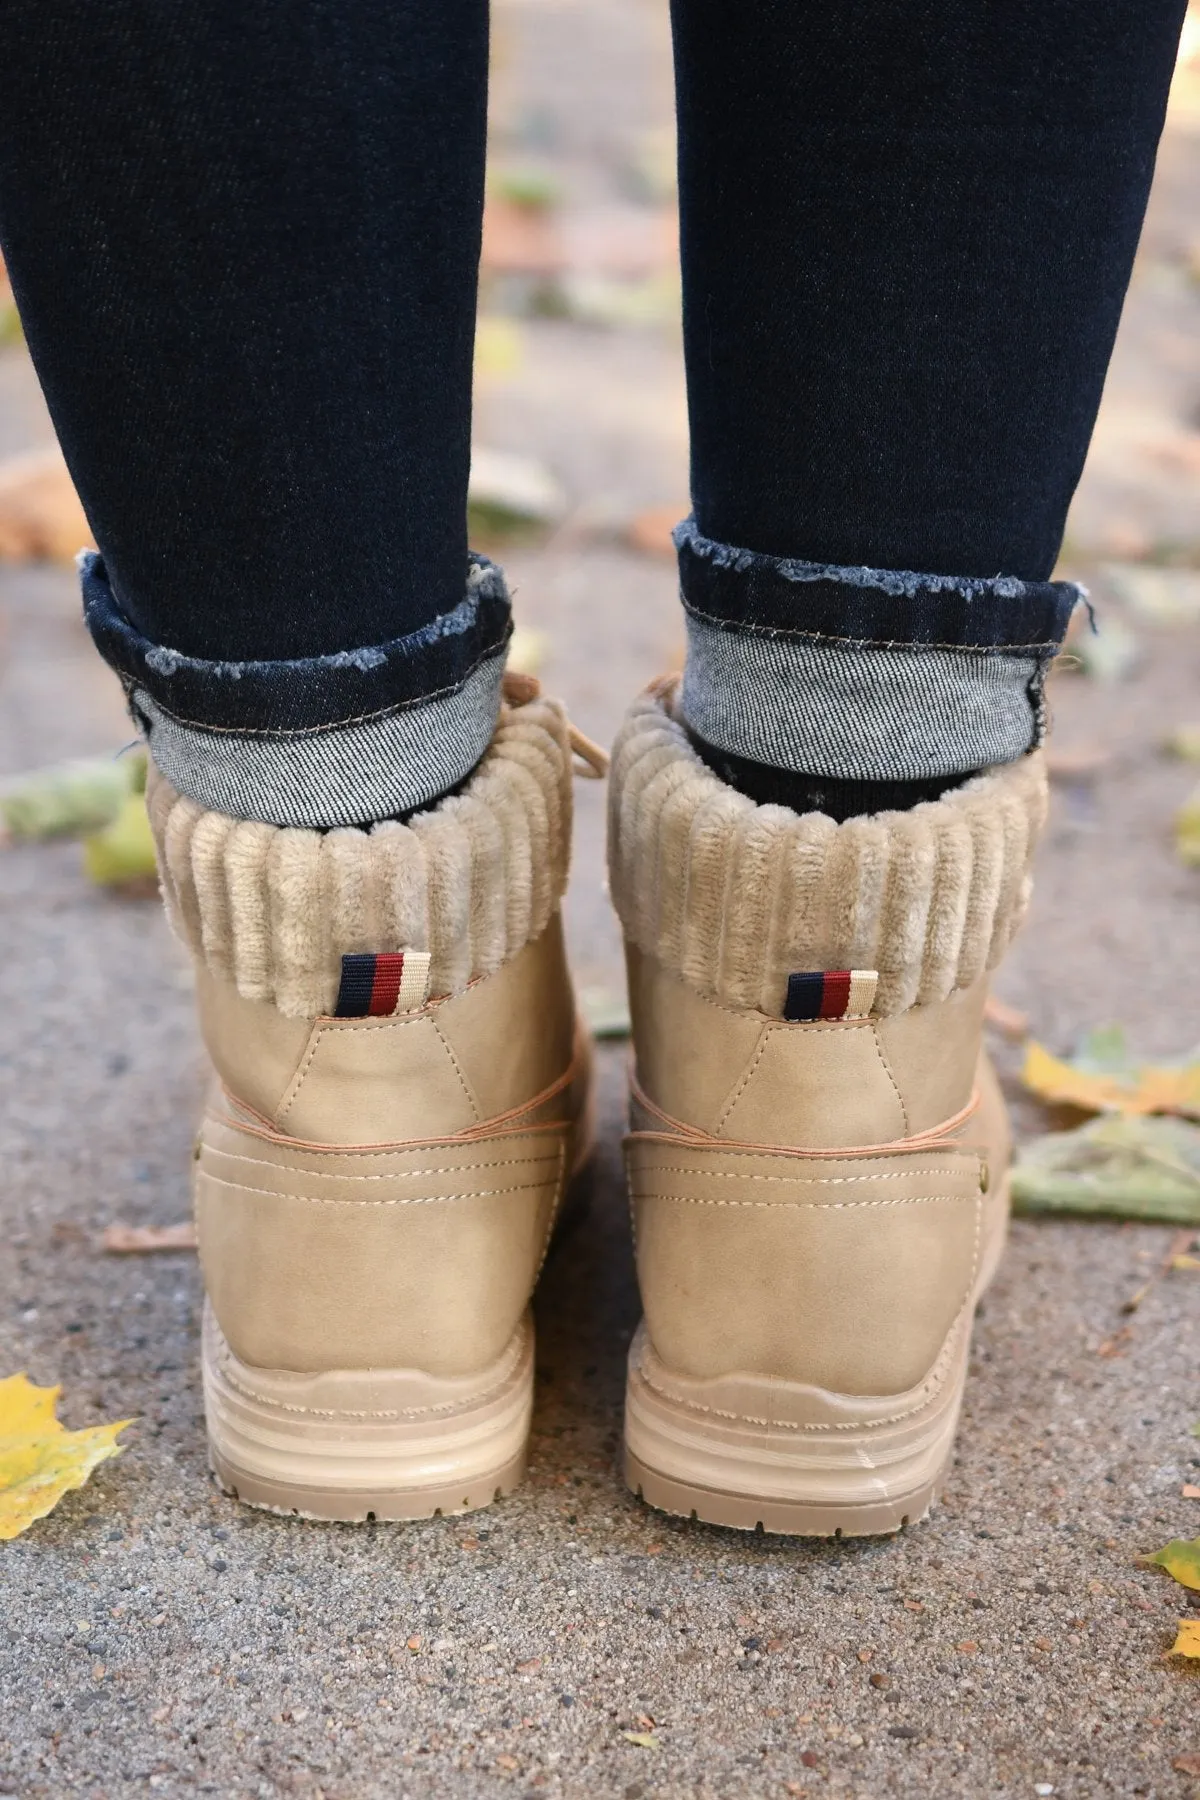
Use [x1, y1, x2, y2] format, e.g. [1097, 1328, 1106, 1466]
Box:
[610, 682, 1045, 1535]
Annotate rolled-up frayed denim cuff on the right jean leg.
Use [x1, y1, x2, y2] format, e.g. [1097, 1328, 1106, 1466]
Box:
[675, 518, 1083, 781]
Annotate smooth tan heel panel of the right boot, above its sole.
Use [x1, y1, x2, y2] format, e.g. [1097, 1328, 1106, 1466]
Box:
[628, 1132, 986, 1395]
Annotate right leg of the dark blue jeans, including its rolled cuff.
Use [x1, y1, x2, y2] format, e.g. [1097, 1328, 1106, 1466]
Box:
[673, 0, 1184, 792]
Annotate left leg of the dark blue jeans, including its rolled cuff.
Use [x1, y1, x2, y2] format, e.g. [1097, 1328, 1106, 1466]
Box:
[0, 0, 492, 824]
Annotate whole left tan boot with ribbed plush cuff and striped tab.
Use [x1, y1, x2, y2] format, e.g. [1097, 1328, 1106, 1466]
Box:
[149, 676, 588, 1519]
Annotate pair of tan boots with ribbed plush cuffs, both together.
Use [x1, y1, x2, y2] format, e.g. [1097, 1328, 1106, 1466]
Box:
[149, 679, 1045, 1535]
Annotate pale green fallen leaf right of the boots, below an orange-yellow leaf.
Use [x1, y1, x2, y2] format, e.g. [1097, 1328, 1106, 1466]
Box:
[1013, 1112, 1200, 1226]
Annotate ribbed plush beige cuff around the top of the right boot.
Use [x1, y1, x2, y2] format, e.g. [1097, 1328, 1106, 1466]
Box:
[608, 677, 1045, 1017]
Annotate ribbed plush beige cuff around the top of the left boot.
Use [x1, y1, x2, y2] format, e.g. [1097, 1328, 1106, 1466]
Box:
[146, 680, 572, 1017]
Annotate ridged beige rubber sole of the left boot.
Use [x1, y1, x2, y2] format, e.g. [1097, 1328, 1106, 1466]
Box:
[203, 1307, 533, 1525]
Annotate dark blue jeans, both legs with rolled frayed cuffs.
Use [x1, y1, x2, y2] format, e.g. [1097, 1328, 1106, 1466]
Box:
[0, 0, 1184, 823]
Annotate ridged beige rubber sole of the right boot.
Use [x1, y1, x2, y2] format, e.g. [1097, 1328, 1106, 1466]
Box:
[624, 1181, 1007, 1537]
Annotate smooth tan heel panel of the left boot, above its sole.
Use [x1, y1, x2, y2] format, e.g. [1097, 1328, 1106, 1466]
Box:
[196, 1112, 570, 1377]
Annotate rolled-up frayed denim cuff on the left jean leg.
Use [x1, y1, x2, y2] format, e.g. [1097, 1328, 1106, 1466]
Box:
[79, 551, 513, 826]
